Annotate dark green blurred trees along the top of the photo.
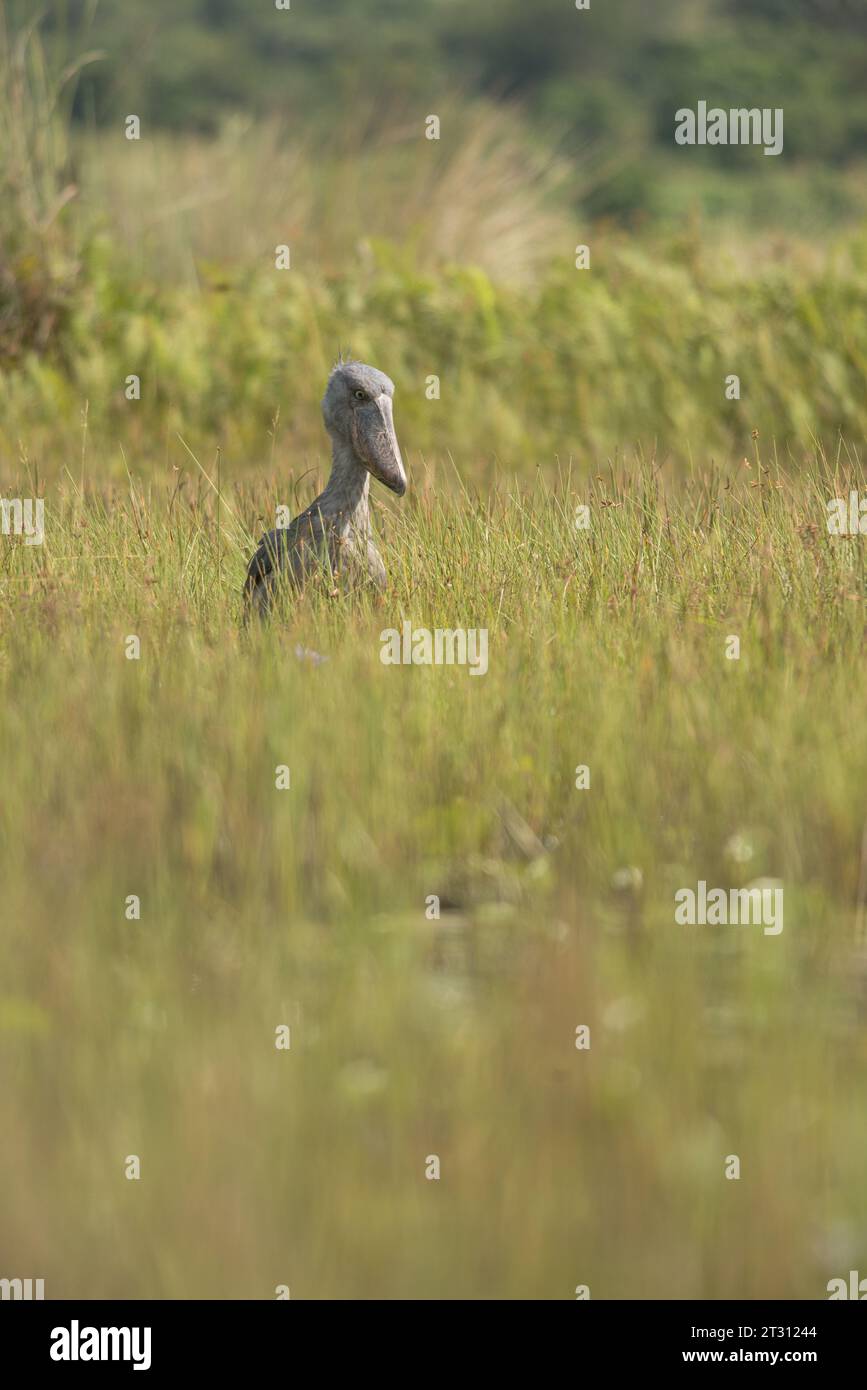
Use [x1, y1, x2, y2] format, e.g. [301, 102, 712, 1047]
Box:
[27, 0, 867, 221]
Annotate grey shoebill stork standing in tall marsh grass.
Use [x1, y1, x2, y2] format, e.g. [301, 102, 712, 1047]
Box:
[245, 361, 407, 614]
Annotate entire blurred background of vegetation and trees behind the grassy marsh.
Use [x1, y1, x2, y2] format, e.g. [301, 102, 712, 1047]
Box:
[0, 0, 867, 477]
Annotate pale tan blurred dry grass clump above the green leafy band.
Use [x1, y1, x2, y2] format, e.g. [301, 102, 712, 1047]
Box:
[79, 93, 579, 284]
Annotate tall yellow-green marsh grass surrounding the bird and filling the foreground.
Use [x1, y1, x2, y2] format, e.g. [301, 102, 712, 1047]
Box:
[0, 455, 867, 1298]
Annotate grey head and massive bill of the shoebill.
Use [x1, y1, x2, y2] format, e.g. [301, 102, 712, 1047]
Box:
[322, 361, 407, 498]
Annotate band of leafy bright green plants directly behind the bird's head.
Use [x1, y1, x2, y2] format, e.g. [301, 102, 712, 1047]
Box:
[0, 226, 867, 480]
